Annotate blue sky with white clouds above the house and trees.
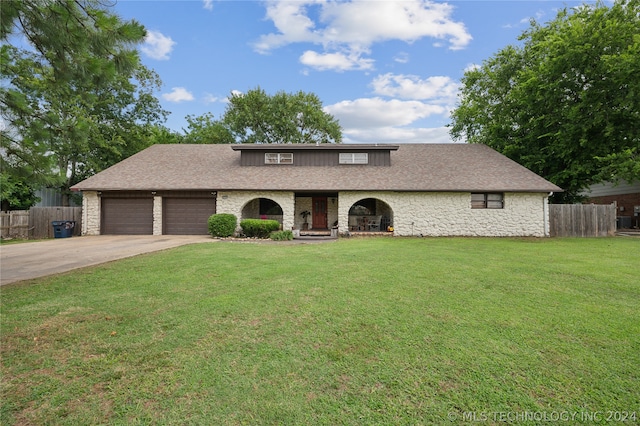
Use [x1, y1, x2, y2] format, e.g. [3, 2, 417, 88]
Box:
[112, 0, 596, 144]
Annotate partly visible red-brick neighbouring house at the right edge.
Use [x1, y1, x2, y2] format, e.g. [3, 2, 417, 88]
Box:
[582, 181, 640, 229]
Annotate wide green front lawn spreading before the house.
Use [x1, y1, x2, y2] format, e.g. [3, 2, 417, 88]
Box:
[0, 238, 640, 425]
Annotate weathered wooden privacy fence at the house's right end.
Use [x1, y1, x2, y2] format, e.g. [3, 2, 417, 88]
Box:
[549, 204, 616, 237]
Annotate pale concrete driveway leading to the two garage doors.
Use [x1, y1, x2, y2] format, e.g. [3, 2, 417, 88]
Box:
[0, 235, 217, 285]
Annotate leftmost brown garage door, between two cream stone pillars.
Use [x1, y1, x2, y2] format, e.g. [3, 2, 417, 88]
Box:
[102, 198, 153, 235]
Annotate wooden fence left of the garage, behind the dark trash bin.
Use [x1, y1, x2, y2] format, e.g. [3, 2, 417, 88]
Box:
[0, 207, 82, 239]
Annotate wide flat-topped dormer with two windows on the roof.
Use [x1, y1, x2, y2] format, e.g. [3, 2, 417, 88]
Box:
[231, 144, 398, 167]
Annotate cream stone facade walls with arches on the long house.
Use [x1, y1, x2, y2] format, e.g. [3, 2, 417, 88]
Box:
[82, 191, 549, 237]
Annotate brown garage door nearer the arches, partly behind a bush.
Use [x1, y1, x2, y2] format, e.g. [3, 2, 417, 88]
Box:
[162, 197, 216, 235]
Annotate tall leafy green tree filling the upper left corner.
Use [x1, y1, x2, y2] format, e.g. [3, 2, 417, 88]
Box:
[0, 0, 166, 206]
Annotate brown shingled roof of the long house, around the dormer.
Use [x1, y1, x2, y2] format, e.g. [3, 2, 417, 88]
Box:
[72, 144, 562, 192]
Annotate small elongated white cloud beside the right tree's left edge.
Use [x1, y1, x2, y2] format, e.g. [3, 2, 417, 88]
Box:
[371, 73, 460, 105]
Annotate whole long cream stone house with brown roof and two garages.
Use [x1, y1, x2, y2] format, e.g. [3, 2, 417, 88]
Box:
[72, 144, 561, 237]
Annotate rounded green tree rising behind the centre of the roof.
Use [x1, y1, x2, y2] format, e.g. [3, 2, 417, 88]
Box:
[221, 87, 342, 144]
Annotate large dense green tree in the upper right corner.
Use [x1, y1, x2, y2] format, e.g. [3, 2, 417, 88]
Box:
[451, 0, 640, 202]
